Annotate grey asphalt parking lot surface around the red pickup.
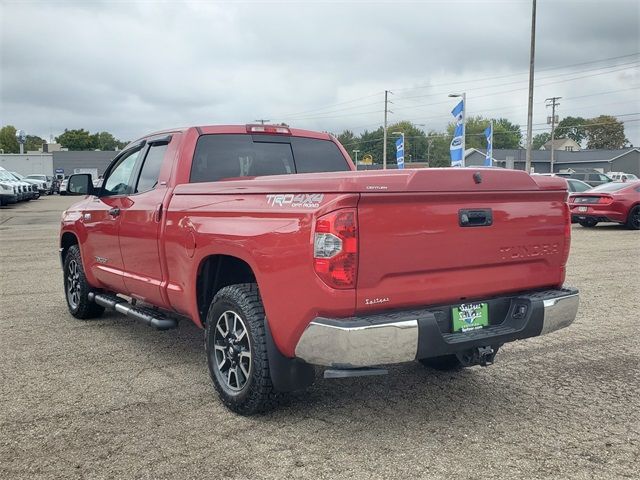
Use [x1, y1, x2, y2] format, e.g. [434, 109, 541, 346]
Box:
[0, 196, 640, 480]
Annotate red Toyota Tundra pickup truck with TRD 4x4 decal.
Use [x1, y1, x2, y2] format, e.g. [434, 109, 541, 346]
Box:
[60, 125, 578, 414]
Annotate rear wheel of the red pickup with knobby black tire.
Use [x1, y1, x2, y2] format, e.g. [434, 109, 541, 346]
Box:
[205, 283, 284, 415]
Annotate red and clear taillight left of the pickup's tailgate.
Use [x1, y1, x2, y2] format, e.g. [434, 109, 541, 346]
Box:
[313, 208, 358, 289]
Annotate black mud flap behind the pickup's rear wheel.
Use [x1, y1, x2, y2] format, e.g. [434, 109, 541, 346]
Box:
[264, 319, 316, 392]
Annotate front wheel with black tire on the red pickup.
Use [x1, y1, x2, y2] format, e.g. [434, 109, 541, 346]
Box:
[64, 245, 104, 320]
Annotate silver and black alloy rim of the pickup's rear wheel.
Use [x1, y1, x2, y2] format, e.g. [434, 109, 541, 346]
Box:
[213, 310, 252, 392]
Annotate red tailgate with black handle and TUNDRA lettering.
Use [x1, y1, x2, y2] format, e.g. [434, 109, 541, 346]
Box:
[357, 170, 569, 311]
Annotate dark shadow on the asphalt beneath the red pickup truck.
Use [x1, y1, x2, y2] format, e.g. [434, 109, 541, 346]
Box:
[100, 313, 530, 433]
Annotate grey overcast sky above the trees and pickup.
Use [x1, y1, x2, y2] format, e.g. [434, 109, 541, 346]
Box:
[0, 0, 640, 145]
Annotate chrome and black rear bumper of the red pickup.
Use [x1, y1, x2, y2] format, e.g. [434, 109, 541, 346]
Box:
[295, 289, 579, 368]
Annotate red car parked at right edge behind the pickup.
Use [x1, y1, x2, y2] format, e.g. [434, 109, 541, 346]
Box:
[569, 181, 640, 230]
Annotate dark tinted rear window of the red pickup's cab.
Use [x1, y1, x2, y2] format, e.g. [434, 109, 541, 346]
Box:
[190, 134, 351, 183]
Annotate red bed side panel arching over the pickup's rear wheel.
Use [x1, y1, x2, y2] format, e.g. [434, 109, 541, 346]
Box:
[164, 191, 358, 357]
